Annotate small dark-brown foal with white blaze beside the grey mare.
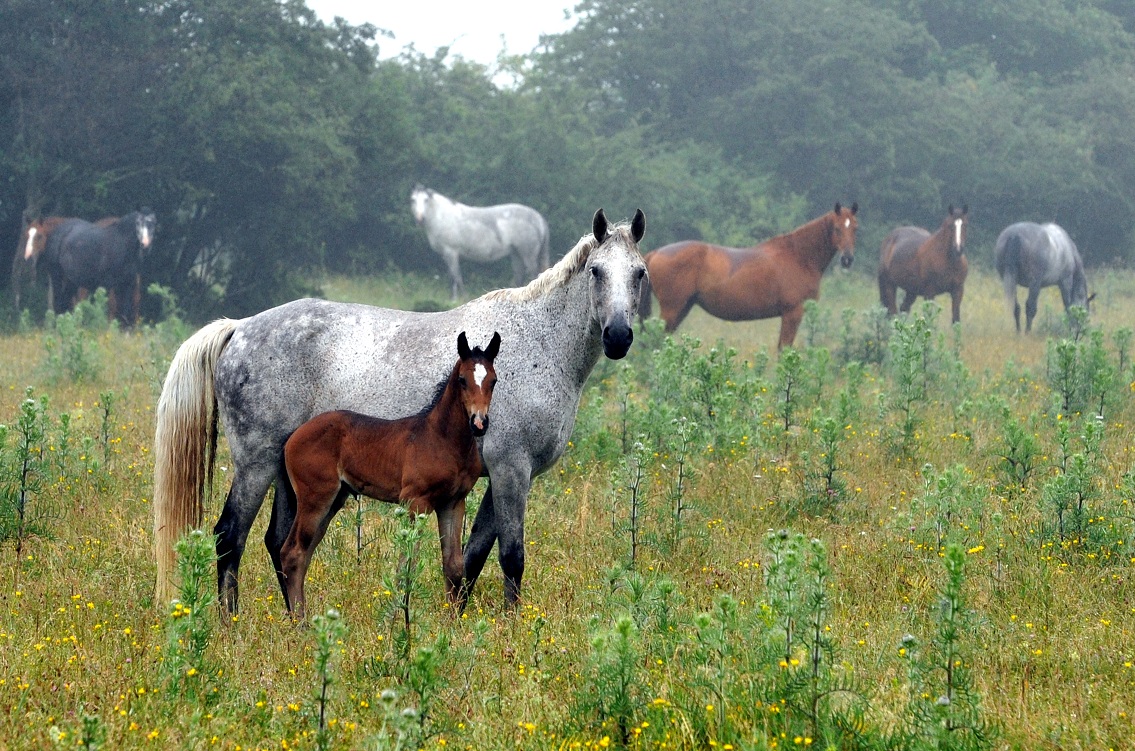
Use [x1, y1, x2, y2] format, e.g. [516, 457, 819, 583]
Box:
[278, 331, 501, 618]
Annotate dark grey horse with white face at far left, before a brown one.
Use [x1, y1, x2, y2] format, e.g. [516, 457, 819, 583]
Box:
[43, 209, 157, 326]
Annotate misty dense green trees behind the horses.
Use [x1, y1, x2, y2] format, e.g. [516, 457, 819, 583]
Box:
[0, 0, 1135, 317]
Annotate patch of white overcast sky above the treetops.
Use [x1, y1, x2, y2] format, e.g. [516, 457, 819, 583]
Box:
[306, 0, 577, 65]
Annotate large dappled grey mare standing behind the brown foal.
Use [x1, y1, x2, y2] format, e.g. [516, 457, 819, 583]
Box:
[153, 210, 646, 611]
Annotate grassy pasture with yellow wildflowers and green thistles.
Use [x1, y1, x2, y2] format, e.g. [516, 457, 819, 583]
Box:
[0, 264, 1135, 750]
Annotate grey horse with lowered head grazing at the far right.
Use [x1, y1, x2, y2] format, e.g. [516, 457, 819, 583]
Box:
[993, 221, 1095, 334]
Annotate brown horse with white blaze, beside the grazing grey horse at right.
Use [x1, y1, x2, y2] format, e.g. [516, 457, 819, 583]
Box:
[878, 205, 969, 323]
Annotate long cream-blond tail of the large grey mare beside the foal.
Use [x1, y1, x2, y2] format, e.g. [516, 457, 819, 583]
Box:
[153, 319, 238, 607]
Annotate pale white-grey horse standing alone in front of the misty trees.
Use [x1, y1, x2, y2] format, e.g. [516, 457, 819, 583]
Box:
[410, 185, 549, 299]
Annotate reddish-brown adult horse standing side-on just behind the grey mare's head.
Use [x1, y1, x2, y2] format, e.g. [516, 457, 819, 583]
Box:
[639, 203, 859, 348]
